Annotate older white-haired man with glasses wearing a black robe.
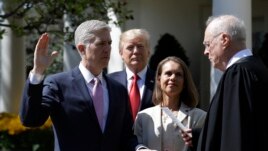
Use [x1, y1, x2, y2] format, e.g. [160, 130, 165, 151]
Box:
[182, 15, 268, 151]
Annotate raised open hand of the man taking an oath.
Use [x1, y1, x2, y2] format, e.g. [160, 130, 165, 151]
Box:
[32, 33, 58, 75]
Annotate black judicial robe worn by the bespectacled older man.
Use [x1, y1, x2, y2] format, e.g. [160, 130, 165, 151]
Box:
[197, 56, 268, 151]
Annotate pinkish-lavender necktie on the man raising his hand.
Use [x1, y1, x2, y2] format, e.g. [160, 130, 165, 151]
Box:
[92, 78, 103, 129]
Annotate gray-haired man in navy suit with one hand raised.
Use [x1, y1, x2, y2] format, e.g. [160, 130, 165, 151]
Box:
[20, 20, 137, 151]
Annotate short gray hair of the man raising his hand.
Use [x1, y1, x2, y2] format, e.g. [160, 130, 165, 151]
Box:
[74, 20, 111, 46]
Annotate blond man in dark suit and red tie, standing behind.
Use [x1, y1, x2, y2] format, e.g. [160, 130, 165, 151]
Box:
[108, 29, 155, 119]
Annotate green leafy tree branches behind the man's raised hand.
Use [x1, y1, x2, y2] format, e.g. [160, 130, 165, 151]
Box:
[0, 0, 133, 72]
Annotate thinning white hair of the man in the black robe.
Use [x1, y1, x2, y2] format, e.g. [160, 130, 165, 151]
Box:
[206, 15, 246, 42]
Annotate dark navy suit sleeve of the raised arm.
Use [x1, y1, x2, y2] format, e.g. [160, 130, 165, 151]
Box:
[20, 76, 60, 127]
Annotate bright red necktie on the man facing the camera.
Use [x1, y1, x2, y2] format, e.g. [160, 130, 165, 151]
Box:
[129, 74, 140, 120]
